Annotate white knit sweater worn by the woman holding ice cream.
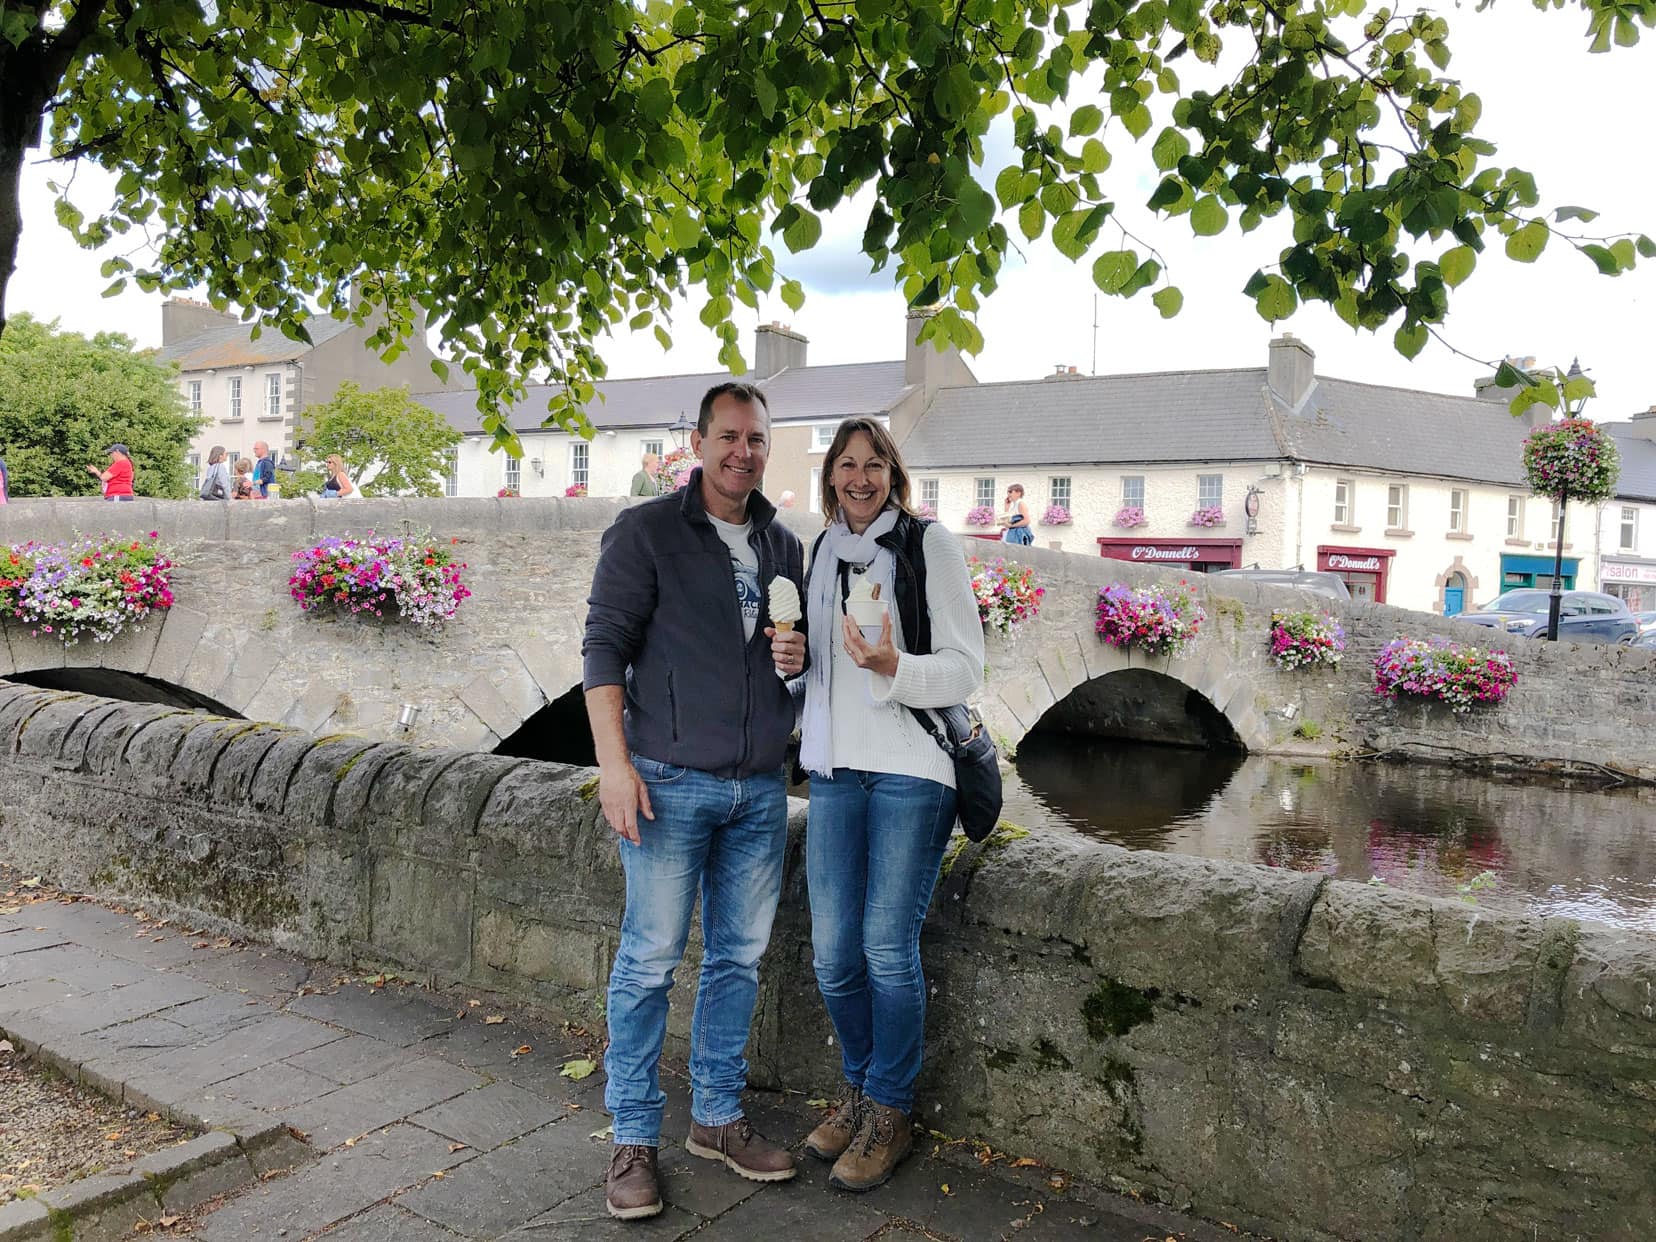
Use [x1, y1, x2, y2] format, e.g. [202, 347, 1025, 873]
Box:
[814, 522, 984, 788]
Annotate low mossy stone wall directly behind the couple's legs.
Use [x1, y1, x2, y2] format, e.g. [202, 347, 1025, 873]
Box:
[0, 686, 1656, 1240]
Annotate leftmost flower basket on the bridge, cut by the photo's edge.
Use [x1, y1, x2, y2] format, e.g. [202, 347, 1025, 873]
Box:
[0, 530, 172, 647]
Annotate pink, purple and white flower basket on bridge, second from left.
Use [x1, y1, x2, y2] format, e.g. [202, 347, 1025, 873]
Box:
[288, 532, 472, 633]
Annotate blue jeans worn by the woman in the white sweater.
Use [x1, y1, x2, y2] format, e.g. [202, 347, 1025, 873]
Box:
[805, 768, 954, 1113]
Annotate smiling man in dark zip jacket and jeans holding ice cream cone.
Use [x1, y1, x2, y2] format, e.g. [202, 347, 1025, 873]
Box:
[581, 383, 805, 1220]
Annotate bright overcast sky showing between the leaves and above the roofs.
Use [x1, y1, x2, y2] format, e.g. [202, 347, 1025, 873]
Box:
[7, 0, 1656, 419]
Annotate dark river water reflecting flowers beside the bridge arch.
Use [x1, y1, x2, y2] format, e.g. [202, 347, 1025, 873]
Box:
[1004, 732, 1656, 931]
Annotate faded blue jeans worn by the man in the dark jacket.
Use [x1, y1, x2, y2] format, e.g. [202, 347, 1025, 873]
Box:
[604, 755, 788, 1148]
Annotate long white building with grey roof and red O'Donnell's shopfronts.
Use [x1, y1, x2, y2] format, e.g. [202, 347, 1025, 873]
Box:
[903, 336, 1596, 613]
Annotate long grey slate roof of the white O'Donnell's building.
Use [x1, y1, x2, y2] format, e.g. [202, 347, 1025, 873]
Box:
[903, 366, 1528, 485]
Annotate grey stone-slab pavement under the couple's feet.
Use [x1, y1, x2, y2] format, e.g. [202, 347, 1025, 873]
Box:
[0, 871, 1234, 1242]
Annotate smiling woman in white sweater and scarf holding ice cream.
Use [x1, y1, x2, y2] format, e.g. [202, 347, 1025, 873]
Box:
[790, 419, 984, 1191]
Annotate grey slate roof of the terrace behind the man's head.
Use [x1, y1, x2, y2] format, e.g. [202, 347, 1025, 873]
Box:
[414, 361, 907, 436]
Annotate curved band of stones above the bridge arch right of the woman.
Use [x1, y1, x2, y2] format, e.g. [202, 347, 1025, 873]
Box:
[982, 631, 1270, 750]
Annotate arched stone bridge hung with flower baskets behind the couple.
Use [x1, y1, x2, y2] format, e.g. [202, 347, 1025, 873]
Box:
[0, 498, 1656, 777]
